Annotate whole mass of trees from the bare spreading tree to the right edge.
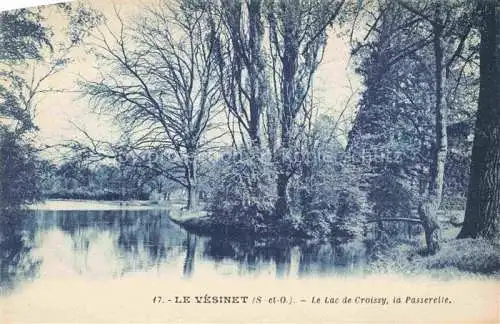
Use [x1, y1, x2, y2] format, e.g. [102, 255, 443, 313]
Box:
[75, 0, 498, 248]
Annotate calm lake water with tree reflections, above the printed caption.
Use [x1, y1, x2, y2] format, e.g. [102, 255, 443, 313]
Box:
[0, 206, 364, 295]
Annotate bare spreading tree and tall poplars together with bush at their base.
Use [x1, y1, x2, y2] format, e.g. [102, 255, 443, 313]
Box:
[82, 0, 360, 238]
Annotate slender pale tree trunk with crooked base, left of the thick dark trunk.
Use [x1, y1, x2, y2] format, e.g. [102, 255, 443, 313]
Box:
[418, 0, 448, 254]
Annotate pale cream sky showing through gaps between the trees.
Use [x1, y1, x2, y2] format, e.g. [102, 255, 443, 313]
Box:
[9, 0, 359, 156]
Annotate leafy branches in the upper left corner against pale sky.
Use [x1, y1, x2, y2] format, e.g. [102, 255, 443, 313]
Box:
[0, 5, 100, 135]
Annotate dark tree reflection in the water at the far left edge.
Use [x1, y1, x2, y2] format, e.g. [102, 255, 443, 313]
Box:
[0, 211, 40, 294]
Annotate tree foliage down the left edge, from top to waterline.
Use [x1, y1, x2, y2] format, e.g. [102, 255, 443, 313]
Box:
[0, 5, 103, 208]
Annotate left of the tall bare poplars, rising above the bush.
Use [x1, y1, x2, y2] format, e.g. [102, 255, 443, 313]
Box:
[219, 0, 268, 148]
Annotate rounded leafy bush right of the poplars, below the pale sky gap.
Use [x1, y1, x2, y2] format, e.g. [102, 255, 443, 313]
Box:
[282, 116, 370, 238]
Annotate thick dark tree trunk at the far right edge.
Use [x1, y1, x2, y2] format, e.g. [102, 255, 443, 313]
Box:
[458, 0, 500, 239]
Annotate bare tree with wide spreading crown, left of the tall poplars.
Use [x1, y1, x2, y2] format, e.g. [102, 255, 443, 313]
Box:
[84, 1, 221, 208]
